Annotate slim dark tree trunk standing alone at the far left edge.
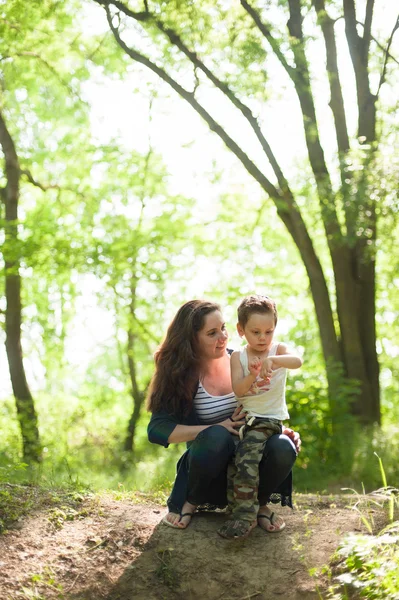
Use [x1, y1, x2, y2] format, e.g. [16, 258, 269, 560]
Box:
[0, 109, 41, 463]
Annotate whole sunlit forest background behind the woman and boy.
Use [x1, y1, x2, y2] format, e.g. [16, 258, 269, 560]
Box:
[0, 0, 399, 492]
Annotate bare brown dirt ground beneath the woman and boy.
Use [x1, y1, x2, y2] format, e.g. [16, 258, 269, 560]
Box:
[0, 495, 380, 600]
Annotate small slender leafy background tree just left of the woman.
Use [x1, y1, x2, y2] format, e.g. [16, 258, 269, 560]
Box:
[86, 144, 192, 451]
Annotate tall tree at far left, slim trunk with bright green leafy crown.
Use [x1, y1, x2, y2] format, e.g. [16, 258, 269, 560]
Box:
[0, 0, 93, 462]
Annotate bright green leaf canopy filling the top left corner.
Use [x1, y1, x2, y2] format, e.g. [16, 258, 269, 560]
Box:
[0, 0, 88, 146]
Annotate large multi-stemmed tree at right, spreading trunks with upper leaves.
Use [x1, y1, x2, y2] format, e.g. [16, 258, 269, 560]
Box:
[94, 0, 399, 423]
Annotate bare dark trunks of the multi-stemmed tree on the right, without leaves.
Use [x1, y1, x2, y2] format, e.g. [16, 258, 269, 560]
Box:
[95, 0, 380, 423]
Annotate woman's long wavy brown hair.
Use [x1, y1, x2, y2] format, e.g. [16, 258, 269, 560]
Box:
[147, 300, 220, 416]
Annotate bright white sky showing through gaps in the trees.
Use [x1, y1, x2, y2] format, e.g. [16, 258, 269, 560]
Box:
[0, 0, 399, 397]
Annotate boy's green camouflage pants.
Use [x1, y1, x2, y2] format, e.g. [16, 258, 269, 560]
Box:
[227, 418, 282, 522]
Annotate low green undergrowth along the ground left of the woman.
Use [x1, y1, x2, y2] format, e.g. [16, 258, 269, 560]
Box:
[0, 381, 184, 501]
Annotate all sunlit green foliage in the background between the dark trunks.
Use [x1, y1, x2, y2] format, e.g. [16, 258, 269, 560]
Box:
[0, 0, 399, 496]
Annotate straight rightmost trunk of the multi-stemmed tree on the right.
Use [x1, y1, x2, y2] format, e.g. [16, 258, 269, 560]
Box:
[343, 0, 381, 422]
